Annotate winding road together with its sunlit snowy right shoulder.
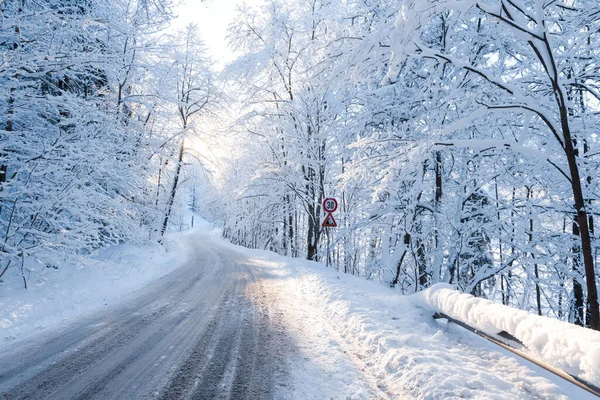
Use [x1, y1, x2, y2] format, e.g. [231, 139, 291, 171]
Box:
[0, 232, 591, 400]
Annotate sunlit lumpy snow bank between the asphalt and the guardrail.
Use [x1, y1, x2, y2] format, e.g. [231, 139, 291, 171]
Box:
[227, 239, 593, 399]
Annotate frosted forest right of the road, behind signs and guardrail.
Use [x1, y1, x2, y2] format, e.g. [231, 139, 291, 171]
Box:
[199, 0, 600, 329]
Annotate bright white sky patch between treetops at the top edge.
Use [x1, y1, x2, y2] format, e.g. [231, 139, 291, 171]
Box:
[174, 0, 262, 65]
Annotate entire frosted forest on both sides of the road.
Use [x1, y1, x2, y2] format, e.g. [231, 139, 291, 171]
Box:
[0, 0, 600, 329]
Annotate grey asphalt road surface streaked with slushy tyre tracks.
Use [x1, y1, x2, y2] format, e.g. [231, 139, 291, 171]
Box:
[0, 236, 293, 399]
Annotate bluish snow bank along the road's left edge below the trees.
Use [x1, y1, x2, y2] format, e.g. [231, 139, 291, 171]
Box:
[0, 230, 190, 346]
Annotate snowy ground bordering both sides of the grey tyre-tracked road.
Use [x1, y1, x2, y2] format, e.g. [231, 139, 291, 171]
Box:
[0, 220, 600, 400]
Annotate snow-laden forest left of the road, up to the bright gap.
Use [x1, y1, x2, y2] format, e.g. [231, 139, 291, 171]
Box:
[0, 0, 217, 288]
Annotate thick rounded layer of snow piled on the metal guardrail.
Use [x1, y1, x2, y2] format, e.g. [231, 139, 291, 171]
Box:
[411, 284, 600, 385]
